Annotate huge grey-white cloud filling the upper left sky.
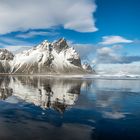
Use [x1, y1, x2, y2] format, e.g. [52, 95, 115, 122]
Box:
[0, 0, 97, 34]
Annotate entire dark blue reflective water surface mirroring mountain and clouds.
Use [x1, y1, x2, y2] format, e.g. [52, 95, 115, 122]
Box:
[0, 76, 140, 140]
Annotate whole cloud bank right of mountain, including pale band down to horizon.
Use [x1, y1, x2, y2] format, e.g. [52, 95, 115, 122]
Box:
[92, 45, 140, 75]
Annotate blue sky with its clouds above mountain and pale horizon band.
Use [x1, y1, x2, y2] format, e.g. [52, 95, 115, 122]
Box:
[0, 0, 140, 64]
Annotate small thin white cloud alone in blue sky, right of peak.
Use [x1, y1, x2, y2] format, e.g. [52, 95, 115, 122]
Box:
[100, 36, 133, 45]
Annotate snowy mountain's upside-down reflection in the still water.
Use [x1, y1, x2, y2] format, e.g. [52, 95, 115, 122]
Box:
[0, 76, 89, 113]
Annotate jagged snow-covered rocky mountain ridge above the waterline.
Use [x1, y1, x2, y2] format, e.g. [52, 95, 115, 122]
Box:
[0, 38, 93, 74]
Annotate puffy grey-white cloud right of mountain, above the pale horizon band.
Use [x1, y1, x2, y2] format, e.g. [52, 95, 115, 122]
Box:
[93, 45, 140, 65]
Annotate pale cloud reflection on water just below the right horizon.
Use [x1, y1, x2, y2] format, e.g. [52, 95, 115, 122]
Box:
[95, 79, 140, 92]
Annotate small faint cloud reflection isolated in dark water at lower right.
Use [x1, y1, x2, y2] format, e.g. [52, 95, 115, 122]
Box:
[103, 111, 129, 119]
